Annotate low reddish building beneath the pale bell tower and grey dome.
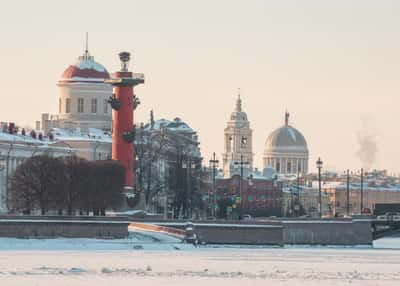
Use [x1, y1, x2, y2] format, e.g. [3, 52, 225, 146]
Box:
[216, 175, 283, 218]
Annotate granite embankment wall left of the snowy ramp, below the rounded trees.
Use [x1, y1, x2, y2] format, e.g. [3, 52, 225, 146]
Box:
[0, 216, 129, 239]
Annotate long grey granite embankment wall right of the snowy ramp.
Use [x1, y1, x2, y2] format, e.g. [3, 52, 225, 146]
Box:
[142, 219, 373, 245]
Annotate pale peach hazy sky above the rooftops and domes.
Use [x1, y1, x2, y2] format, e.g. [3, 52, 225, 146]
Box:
[0, 0, 400, 173]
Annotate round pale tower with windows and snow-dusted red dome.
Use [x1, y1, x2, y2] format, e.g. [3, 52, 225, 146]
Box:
[37, 36, 112, 133]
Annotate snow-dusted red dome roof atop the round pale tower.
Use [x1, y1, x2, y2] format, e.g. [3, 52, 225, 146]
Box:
[59, 51, 110, 83]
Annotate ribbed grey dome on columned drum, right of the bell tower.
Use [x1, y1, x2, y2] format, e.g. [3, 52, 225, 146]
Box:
[263, 111, 308, 174]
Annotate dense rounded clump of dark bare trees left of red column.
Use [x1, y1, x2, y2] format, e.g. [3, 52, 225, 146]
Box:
[10, 155, 125, 215]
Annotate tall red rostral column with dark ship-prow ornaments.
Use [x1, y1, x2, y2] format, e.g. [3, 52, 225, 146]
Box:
[105, 52, 144, 193]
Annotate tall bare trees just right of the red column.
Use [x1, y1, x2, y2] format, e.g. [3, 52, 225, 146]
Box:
[134, 123, 204, 218]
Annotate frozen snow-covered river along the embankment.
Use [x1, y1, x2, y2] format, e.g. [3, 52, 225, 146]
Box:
[0, 233, 400, 286]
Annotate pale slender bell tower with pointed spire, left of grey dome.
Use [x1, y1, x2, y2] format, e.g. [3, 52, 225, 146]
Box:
[222, 93, 254, 178]
